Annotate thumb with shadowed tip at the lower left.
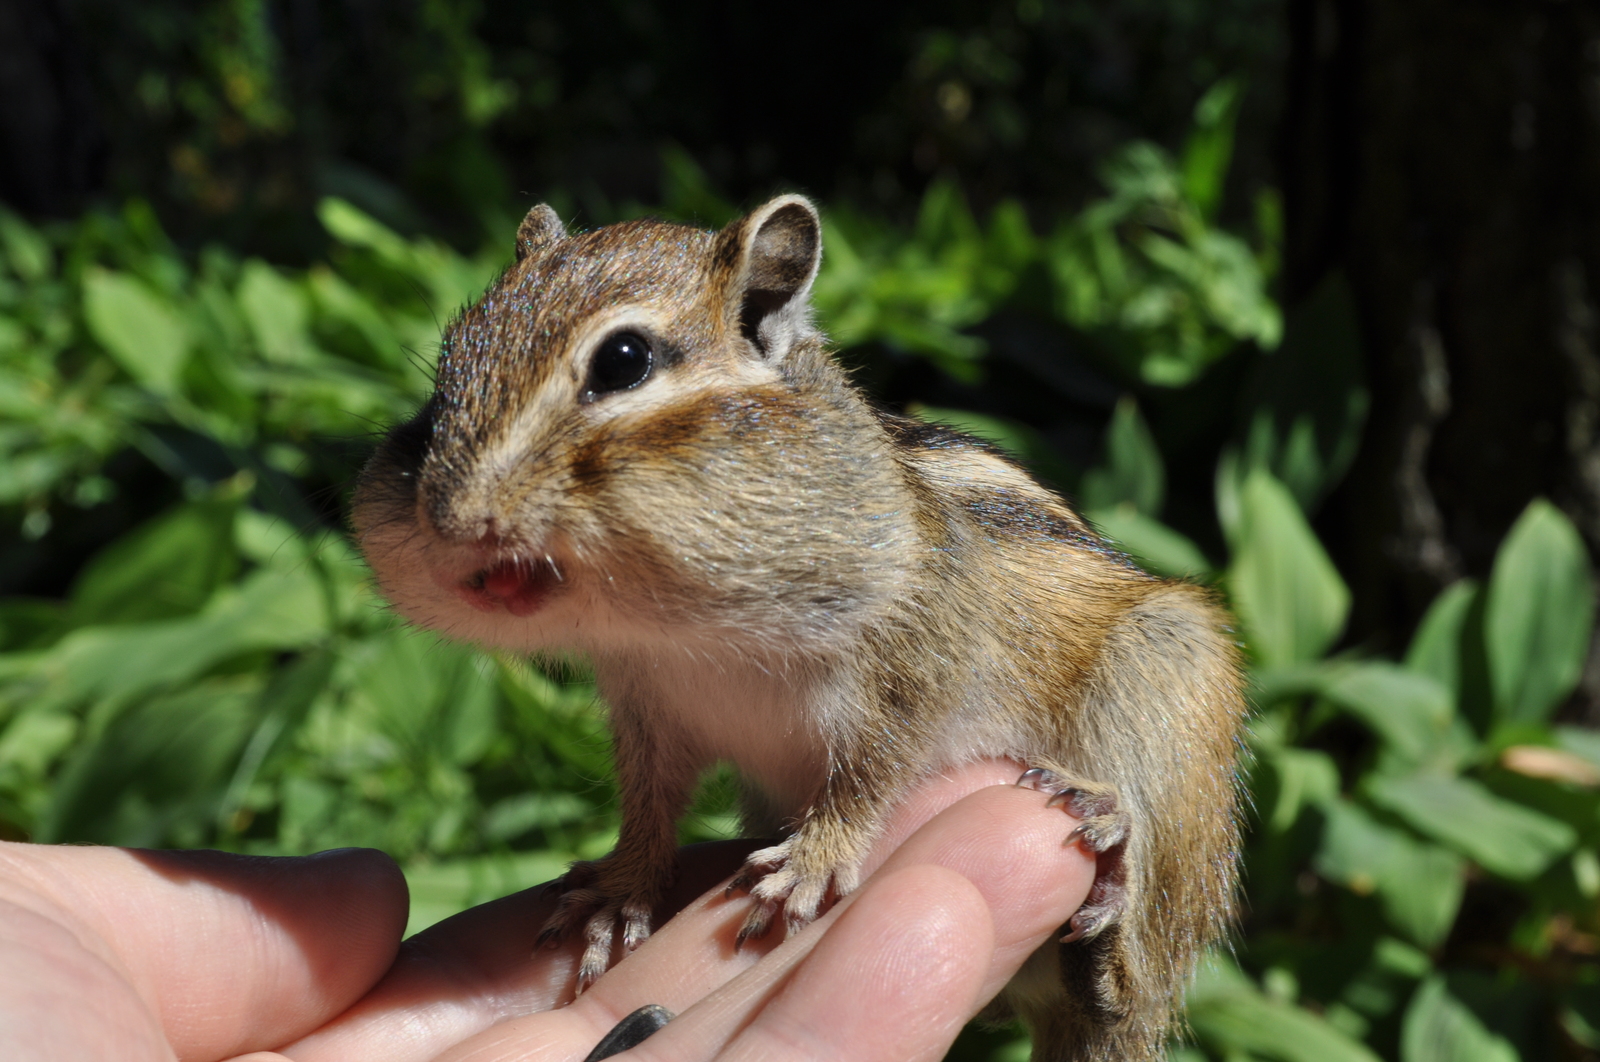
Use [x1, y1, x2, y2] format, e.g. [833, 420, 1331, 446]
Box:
[0, 843, 406, 1062]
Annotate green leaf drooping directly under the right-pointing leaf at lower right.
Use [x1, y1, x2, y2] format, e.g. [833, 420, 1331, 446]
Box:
[1317, 800, 1466, 947]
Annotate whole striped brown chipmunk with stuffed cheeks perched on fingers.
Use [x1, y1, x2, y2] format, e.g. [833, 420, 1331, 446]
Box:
[354, 195, 1245, 1060]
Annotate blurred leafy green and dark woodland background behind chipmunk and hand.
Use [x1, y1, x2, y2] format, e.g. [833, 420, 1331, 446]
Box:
[0, 0, 1600, 1062]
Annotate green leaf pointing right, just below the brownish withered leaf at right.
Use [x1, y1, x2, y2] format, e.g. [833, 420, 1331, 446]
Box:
[1368, 774, 1578, 881]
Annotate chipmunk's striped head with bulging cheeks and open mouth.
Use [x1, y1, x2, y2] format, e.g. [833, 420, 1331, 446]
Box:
[354, 195, 899, 648]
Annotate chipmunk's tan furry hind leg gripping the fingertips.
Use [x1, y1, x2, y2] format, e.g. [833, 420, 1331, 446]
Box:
[1006, 584, 1245, 1062]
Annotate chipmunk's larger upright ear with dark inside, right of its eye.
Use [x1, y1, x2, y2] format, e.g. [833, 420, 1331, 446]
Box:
[717, 195, 822, 360]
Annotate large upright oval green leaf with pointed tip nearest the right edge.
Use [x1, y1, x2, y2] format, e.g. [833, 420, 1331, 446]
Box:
[1483, 499, 1595, 723]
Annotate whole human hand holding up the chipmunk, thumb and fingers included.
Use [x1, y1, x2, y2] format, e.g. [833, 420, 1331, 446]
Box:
[0, 763, 1094, 1062]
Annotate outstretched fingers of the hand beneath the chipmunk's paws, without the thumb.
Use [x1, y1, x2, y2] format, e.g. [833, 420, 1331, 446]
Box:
[282, 761, 1094, 1062]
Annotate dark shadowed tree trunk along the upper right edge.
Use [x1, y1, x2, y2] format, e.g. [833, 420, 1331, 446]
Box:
[1285, 0, 1600, 694]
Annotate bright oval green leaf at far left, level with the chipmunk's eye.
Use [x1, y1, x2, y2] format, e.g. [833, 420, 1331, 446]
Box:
[83, 267, 189, 395]
